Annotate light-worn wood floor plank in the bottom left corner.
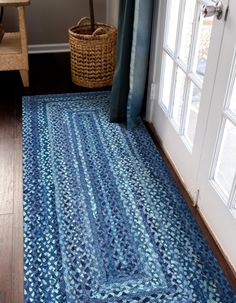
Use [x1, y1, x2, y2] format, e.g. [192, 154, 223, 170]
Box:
[0, 215, 12, 303]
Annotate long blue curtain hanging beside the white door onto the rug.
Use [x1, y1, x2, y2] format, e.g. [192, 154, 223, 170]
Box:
[110, 0, 154, 128]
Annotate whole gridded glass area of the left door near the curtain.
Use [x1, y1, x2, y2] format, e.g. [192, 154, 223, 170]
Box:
[159, 0, 213, 152]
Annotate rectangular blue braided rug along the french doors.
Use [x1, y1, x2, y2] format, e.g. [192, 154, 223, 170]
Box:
[23, 92, 236, 303]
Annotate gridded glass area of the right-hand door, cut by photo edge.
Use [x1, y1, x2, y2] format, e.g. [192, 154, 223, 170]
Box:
[210, 49, 236, 214]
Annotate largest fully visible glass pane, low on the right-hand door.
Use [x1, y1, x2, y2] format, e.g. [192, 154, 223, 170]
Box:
[214, 120, 236, 196]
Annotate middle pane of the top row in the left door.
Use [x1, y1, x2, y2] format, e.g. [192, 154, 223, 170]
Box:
[179, 0, 196, 65]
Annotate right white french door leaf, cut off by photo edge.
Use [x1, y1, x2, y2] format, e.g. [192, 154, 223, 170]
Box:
[198, 0, 236, 269]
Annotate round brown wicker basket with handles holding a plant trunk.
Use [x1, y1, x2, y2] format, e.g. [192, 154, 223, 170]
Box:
[69, 17, 117, 88]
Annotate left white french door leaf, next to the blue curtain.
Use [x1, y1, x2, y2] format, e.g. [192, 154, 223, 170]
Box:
[149, 0, 228, 198]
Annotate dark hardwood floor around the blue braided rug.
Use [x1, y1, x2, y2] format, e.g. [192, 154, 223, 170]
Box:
[0, 53, 236, 303]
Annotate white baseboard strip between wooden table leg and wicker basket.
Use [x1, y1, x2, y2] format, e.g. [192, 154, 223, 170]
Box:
[29, 43, 70, 54]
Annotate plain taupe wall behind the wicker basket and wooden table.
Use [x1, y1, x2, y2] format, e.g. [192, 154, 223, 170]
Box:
[4, 0, 109, 45]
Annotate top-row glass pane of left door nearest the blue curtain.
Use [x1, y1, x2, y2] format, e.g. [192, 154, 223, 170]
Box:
[165, 0, 180, 52]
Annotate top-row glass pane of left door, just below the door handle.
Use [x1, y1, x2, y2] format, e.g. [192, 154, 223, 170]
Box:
[193, 17, 214, 80]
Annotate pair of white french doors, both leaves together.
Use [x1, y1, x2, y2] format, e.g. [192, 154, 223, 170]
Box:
[147, 0, 236, 269]
